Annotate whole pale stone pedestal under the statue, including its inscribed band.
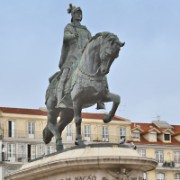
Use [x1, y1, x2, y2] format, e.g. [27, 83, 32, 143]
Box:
[5, 143, 157, 180]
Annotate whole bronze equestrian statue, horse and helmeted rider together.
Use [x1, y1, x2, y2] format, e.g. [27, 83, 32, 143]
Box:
[43, 5, 125, 151]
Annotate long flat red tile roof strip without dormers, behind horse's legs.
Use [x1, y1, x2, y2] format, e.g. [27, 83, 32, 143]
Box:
[0, 107, 129, 121]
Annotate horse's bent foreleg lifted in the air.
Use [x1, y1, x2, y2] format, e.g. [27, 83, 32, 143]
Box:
[103, 93, 120, 123]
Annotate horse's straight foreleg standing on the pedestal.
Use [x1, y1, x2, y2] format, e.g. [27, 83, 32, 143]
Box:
[73, 101, 84, 145]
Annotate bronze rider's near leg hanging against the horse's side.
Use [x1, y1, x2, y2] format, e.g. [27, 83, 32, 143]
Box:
[56, 68, 69, 108]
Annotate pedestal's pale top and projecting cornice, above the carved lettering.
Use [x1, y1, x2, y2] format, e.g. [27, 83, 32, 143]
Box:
[5, 146, 157, 180]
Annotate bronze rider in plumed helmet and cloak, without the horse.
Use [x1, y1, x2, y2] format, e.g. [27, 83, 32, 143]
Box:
[56, 4, 104, 109]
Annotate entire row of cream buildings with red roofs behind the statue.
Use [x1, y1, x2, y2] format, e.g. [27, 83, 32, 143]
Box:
[0, 107, 180, 180]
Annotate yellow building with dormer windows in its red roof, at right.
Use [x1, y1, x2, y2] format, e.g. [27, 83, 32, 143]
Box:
[131, 121, 180, 180]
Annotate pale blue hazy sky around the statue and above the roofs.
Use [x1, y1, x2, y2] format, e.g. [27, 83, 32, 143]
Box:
[0, 0, 180, 124]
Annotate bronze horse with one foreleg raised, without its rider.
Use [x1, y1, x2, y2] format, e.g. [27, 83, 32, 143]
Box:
[43, 32, 125, 151]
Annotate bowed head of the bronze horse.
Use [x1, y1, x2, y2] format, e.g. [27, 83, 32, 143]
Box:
[99, 32, 125, 75]
